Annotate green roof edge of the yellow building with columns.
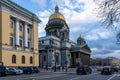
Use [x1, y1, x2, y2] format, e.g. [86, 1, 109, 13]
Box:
[0, 0, 41, 22]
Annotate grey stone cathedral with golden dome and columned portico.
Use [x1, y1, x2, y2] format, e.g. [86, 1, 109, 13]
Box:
[39, 5, 91, 67]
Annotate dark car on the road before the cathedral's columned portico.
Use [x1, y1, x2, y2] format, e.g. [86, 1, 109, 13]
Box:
[76, 66, 92, 74]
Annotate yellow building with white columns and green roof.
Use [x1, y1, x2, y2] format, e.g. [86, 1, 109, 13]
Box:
[0, 0, 41, 67]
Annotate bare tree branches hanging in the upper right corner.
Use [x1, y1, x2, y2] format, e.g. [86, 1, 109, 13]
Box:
[94, 0, 120, 42]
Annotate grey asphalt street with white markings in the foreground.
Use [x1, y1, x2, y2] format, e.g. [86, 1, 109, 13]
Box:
[0, 68, 120, 80]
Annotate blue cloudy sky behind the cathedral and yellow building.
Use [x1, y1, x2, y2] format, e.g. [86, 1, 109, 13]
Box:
[12, 0, 120, 58]
